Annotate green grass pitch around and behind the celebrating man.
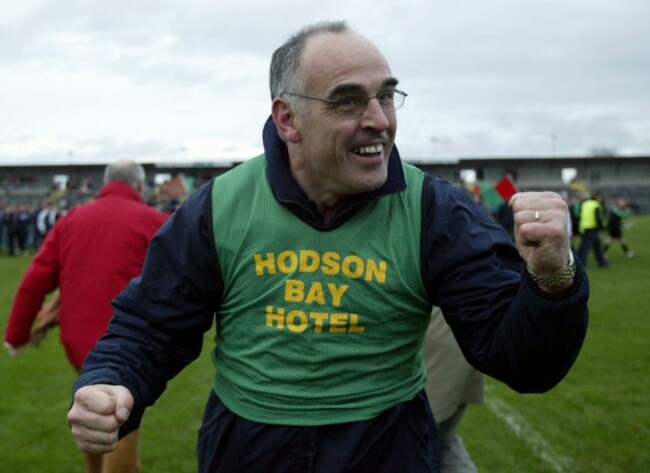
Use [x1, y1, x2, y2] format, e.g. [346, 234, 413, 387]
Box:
[0, 216, 650, 473]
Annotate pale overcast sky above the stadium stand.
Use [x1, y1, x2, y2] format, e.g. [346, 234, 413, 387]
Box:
[0, 0, 650, 164]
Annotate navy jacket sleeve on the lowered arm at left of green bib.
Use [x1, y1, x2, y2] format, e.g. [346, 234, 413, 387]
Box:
[74, 184, 222, 436]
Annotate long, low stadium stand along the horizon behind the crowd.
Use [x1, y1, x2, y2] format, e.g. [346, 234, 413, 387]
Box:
[0, 156, 650, 213]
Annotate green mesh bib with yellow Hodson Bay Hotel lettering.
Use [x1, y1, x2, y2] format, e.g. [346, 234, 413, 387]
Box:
[212, 155, 431, 425]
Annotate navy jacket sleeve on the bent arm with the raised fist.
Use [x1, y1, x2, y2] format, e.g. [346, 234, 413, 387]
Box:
[422, 178, 589, 392]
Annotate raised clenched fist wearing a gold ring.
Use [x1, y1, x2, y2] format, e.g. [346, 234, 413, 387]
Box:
[509, 192, 571, 276]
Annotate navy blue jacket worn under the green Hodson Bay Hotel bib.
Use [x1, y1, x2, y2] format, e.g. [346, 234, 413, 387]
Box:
[75, 120, 589, 435]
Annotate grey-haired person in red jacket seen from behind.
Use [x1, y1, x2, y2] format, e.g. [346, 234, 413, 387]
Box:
[4, 160, 167, 473]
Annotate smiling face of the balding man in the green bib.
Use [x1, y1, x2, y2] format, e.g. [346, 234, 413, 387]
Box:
[290, 33, 397, 205]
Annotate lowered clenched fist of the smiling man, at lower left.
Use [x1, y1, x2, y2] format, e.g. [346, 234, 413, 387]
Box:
[68, 384, 133, 453]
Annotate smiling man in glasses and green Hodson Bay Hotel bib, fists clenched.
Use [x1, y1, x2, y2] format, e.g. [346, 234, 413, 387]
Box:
[68, 22, 589, 473]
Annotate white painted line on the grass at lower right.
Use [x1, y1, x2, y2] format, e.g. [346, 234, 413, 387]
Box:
[485, 396, 573, 473]
